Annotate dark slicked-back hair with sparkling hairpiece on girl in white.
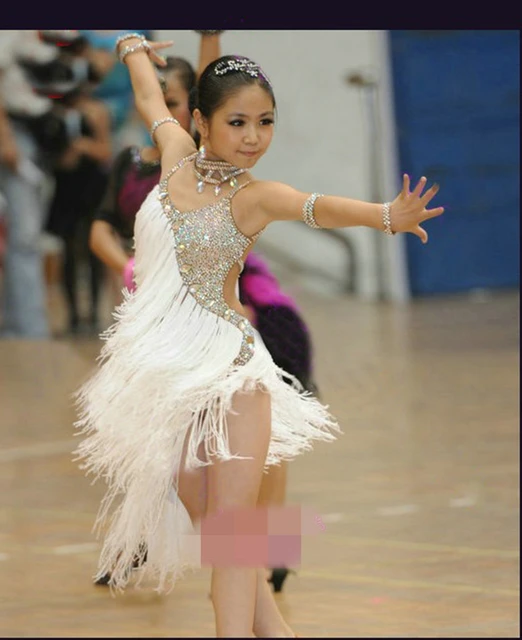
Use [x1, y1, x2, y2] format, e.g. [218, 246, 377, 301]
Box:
[189, 56, 276, 118]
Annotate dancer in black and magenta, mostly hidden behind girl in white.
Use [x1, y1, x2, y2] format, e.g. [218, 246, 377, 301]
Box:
[89, 32, 316, 592]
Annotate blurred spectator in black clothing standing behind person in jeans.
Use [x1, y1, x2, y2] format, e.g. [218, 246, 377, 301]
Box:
[31, 31, 115, 335]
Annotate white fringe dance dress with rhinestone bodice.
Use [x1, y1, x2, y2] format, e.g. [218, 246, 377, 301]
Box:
[75, 154, 339, 591]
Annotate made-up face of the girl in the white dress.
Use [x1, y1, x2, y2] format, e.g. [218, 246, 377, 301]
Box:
[194, 84, 275, 169]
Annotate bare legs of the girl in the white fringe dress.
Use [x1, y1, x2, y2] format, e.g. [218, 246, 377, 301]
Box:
[178, 384, 293, 638]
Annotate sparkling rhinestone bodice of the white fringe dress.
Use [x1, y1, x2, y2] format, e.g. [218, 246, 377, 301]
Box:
[154, 154, 260, 365]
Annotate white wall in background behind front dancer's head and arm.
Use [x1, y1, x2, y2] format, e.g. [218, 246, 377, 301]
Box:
[155, 30, 407, 300]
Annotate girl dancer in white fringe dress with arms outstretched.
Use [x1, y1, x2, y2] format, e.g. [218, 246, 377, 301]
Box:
[73, 34, 443, 638]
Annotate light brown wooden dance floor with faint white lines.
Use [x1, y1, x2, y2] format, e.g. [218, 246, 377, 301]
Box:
[0, 282, 520, 638]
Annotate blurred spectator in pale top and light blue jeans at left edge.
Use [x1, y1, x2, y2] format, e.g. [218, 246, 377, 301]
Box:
[0, 30, 57, 339]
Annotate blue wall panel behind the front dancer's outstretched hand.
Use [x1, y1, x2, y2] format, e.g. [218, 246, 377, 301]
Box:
[390, 30, 520, 295]
